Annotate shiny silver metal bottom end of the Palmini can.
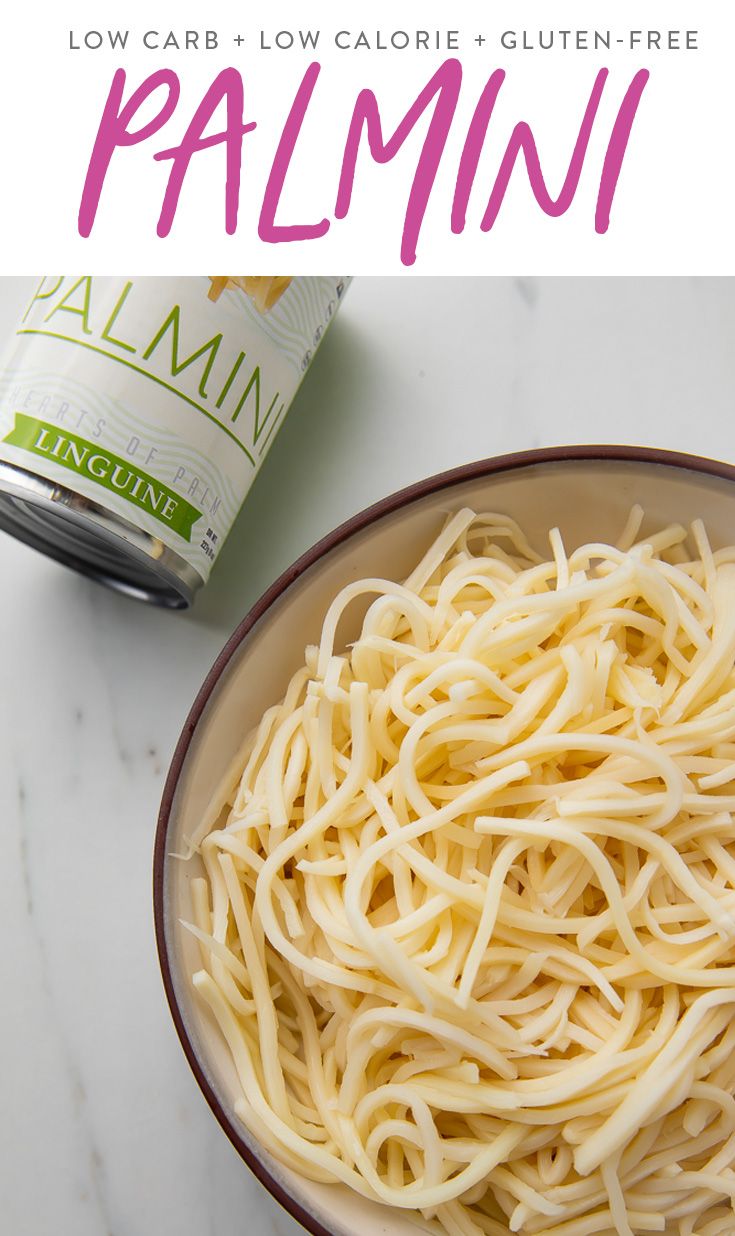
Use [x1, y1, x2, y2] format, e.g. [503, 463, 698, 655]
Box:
[0, 462, 204, 609]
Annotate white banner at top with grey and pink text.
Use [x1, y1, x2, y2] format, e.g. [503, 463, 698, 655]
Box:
[0, 0, 735, 274]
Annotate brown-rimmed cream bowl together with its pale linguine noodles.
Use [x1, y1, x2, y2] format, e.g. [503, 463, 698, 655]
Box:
[153, 446, 735, 1236]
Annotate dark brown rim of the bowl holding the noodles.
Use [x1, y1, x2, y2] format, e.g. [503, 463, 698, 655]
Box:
[153, 445, 735, 1236]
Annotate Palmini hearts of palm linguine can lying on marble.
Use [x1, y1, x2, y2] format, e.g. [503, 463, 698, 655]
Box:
[0, 276, 348, 609]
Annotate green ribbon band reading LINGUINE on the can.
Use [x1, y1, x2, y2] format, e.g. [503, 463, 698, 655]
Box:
[2, 412, 201, 541]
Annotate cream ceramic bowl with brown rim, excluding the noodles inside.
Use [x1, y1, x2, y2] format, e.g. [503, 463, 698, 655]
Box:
[153, 446, 735, 1236]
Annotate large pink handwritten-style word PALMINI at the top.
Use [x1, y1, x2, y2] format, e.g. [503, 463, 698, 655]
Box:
[78, 59, 650, 266]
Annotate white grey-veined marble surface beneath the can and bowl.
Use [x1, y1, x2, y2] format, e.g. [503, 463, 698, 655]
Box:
[0, 278, 735, 1236]
